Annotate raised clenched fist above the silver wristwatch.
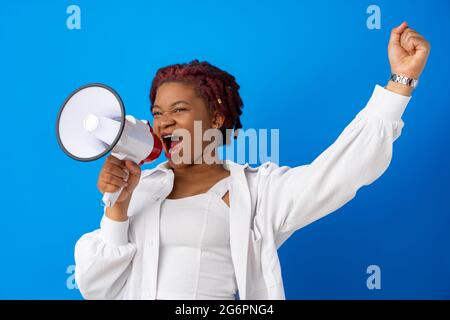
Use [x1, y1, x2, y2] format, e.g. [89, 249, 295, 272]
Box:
[388, 22, 431, 79]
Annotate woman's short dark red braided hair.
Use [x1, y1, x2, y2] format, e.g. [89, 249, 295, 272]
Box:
[150, 60, 243, 143]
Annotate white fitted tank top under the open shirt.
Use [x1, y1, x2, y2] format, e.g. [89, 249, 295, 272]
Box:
[156, 177, 237, 300]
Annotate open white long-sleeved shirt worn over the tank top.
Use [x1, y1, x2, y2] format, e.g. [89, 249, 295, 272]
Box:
[75, 85, 410, 299]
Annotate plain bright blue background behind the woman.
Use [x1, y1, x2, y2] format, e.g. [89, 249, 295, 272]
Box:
[0, 0, 450, 299]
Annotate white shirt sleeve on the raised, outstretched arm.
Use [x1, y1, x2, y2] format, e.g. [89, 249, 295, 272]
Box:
[258, 85, 410, 242]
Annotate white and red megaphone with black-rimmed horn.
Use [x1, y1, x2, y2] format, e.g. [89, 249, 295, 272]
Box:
[56, 83, 162, 207]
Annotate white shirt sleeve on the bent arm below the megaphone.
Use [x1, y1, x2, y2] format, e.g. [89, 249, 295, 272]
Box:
[75, 215, 136, 300]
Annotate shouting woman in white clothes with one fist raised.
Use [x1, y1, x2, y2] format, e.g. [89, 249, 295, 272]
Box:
[75, 23, 430, 299]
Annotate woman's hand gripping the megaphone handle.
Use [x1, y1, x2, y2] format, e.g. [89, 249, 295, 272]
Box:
[97, 155, 141, 221]
